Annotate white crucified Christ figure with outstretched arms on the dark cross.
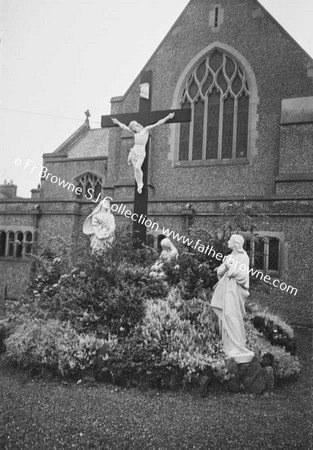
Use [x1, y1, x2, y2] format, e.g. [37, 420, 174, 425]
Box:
[112, 113, 174, 194]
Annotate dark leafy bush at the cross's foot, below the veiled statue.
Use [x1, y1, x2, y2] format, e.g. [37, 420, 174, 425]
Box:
[13, 229, 167, 337]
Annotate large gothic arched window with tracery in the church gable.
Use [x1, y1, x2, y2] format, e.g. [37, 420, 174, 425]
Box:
[179, 49, 250, 161]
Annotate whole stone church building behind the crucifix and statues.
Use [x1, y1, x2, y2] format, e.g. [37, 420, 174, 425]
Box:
[0, 0, 313, 324]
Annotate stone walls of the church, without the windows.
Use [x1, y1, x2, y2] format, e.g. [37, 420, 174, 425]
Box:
[0, 0, 313, 324]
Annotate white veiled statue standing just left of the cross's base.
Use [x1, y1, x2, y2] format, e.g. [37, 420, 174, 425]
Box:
[83, 200, 115, 254]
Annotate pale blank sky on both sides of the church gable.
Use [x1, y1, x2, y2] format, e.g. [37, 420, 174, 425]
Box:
[0, 0, 313, 197]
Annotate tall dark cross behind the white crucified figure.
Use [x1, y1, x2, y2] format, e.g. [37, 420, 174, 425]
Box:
[101, 70, 191, 248]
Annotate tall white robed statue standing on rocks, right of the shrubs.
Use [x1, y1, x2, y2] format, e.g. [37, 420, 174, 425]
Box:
[211, 234, 254, 363]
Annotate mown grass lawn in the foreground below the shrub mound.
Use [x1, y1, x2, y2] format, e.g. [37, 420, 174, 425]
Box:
[0, 329, 313, 450]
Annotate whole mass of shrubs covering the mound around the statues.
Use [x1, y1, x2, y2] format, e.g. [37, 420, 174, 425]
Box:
[0, 224, 300, 389]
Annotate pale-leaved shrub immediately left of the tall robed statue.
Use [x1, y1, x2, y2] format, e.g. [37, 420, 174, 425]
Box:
[141, 292, 226, 381]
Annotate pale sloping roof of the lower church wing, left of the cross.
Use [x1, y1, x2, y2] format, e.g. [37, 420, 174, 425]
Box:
[43, 118, 109, 158]
